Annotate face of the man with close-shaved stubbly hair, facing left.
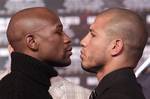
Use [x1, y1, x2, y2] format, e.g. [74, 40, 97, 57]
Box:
[80, 19, 109, 72]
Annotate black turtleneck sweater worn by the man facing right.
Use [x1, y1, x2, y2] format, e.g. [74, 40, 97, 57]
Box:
[0, 52, 57, 99]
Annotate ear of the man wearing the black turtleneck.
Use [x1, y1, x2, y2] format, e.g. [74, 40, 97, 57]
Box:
[25, 34, 39, 51]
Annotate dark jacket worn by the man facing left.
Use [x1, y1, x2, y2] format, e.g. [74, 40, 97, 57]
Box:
[91, 68, 145, 99]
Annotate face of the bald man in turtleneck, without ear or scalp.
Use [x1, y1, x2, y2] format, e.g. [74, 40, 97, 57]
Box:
[35, 19, 72, 66]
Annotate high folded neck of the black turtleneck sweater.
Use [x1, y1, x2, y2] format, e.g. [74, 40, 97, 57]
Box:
[11, 52, 57, 89]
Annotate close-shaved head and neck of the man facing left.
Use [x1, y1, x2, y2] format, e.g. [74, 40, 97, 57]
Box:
[80, 8, 148, 73]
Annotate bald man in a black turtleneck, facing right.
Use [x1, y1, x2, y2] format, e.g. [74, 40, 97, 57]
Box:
[0, 7, 72, 99]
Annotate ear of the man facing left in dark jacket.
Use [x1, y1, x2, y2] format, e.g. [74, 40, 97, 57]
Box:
[111, 39, 124, 56]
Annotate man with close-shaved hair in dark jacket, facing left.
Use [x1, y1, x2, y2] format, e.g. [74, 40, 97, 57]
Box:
[81, 8, 148, 99]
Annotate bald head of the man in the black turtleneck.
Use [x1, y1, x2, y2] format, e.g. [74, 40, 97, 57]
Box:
[7, 7, 72, 66]
